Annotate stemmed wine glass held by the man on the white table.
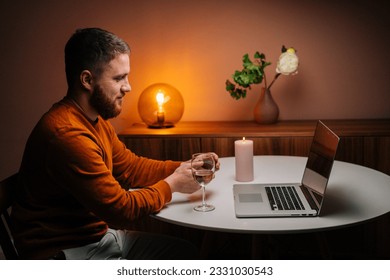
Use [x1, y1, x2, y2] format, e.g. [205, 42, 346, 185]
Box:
[191, 153, 215, 212]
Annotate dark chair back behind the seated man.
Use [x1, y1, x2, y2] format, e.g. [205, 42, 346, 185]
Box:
[0, 173, 18, 259]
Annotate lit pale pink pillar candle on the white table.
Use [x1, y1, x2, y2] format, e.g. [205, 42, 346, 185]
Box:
[234, 137, 253, 182]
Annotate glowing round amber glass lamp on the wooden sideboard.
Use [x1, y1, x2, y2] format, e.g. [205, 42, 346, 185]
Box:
[138, 83, 184, 128]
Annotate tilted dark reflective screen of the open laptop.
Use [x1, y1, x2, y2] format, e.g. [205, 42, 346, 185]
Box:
[302, 121, 339, 209]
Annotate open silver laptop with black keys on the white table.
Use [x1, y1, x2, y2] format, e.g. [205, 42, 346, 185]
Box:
[233, 121, 340, 218]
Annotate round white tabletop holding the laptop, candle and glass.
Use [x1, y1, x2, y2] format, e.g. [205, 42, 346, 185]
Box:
[153, 156, 390, 234]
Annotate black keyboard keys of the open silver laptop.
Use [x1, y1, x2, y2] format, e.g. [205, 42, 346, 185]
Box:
[265, 186, 305, 210]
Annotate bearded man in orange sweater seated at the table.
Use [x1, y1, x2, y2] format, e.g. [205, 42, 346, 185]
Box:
[12, 28, 218, 259]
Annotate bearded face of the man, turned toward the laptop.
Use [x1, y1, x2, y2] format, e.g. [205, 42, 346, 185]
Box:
[90, 54, 131, 120]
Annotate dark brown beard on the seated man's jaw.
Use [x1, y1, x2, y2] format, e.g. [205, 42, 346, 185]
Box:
[91, 85, 121, 120]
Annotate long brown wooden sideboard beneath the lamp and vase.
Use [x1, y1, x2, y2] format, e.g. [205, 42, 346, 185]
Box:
[118, 119, 390, 175]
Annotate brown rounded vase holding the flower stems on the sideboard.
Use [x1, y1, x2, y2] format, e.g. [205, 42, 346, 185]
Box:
[254, 88, 279, 124]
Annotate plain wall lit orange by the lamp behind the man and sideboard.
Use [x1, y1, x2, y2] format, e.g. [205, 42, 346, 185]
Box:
[0, 0, 390, 177]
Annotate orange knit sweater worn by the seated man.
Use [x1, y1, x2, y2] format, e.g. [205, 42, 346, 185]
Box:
[11, 97, 180, 259]
